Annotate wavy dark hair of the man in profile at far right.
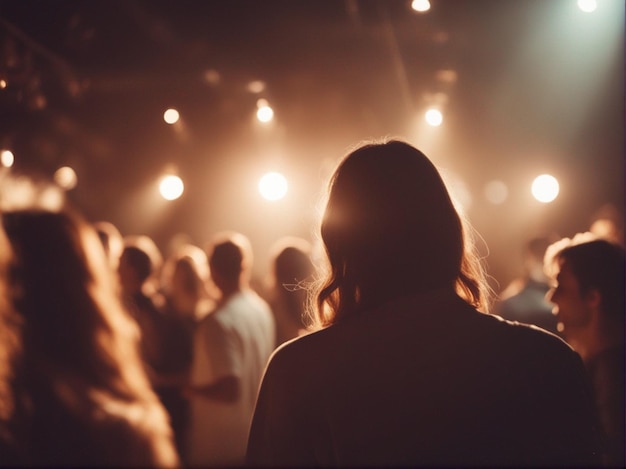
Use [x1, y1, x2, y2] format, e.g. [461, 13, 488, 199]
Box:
[546, 238, 626, 321]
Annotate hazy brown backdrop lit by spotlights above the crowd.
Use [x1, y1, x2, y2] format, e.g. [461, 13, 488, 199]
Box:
[0, 0, 624, 289]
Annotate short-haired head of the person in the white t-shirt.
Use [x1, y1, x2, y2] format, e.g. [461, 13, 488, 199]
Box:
[207, 232, 252, 288]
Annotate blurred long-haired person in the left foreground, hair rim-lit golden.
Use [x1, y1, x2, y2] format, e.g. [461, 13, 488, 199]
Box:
[0, 175, 177, 465]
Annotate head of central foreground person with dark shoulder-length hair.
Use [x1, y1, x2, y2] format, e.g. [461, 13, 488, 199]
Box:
[318, 140, 486, 323]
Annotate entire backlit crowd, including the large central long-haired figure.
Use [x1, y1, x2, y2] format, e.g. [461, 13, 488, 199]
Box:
[0, 139, 625, 467]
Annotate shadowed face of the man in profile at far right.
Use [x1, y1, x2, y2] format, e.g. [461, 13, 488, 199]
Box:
[546, 262, 591, 339]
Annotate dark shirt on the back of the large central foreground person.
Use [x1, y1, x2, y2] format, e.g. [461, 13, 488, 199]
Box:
[247, 293, 599, 467]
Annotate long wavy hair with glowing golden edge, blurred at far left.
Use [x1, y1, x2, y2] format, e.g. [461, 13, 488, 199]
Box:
[2, 209, 178, 465]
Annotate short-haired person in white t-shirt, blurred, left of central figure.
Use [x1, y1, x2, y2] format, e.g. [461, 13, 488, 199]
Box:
[188, 233, 275, 466]
